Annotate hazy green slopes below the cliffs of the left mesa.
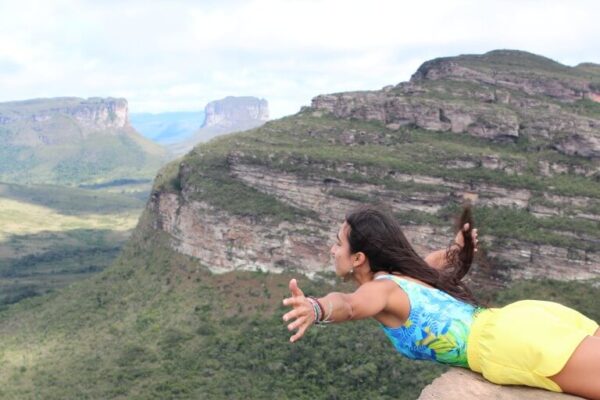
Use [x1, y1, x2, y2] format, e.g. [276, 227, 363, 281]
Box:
[0, 110, 167, 185]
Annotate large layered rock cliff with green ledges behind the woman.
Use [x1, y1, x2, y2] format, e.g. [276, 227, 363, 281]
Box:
[148, 53, 600, 286]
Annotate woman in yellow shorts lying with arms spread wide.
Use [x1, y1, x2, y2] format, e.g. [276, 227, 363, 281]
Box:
[283, 207, 600, 400]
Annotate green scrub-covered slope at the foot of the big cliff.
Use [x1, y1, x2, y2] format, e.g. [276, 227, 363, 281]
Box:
[0, 214, 600, 399]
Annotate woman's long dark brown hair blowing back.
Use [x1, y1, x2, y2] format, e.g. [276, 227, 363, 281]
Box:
[346, 205, 484, 306]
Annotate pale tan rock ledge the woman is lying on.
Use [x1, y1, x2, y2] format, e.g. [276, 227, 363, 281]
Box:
[418, 368, 583, 400]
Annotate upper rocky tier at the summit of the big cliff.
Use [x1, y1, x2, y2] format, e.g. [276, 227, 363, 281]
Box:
[311, 51, 600, 158]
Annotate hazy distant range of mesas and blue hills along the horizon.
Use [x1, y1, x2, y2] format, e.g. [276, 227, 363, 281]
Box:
[0, 96, 269, 185]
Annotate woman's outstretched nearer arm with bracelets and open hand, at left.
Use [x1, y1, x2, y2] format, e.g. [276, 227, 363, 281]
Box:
[283, 279, 394, 342]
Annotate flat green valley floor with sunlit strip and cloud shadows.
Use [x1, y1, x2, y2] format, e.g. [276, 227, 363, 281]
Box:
[0, 184, 145, 305]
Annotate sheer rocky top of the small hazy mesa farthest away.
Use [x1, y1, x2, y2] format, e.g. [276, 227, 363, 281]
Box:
[202, 96, 269, 128]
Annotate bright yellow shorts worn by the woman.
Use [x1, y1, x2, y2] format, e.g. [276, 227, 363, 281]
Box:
[467, 300, 598, 392]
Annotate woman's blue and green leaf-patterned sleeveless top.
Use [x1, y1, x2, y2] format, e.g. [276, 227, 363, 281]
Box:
[375, 275, 484, 368]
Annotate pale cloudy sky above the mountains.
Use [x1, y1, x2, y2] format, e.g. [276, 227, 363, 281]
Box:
[0, 0, 600, 118]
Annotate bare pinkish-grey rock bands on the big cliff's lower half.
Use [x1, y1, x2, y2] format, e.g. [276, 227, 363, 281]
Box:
[149, 157, 600, 286]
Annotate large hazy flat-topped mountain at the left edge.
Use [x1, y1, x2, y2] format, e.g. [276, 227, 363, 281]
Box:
[0, 97, 167, 183]
